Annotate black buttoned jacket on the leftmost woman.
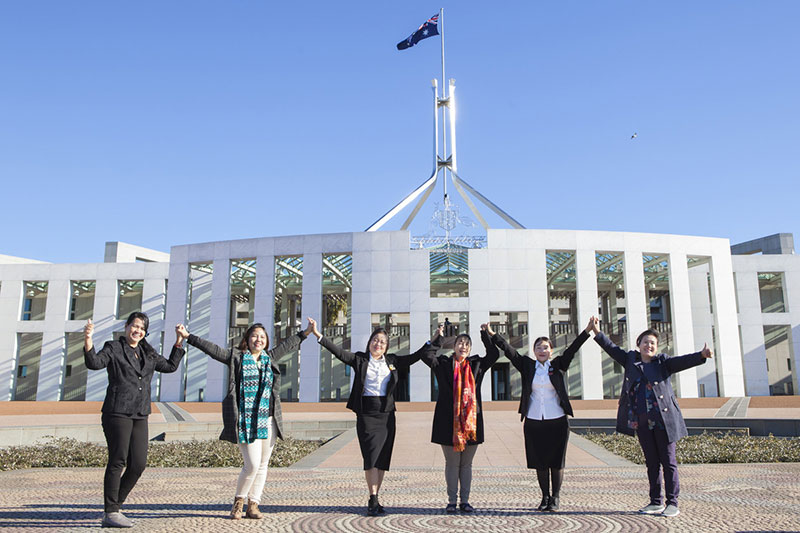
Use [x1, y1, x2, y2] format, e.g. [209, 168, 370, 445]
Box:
[83, 337, 186, 416]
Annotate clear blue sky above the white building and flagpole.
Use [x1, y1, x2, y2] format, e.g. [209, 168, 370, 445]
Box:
[0, 0, 800, 262]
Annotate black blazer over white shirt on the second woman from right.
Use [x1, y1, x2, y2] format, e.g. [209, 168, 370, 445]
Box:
[492, 330, 589, 420]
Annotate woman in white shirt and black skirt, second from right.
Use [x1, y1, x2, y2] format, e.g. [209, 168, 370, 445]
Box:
[487, 321, 592, 512]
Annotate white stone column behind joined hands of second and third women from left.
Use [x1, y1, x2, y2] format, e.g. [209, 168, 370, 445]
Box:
[299, 251, 322, 402]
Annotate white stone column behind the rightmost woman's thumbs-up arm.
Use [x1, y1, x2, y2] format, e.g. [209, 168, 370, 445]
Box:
[668, 252, 696, 398]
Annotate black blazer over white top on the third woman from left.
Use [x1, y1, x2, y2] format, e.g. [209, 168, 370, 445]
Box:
[319, 337, 439, 414]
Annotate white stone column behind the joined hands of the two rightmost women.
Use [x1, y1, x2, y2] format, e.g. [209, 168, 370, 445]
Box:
[575, 248, 603, 400]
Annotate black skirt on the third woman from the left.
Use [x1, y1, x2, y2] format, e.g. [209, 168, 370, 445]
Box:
[356, 396, 396, 470]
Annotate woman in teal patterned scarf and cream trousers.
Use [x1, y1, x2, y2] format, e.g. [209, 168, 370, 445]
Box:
[178, 318, 315, 520]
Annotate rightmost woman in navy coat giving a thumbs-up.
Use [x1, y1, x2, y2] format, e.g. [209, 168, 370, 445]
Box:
[592, 318, 711, 516]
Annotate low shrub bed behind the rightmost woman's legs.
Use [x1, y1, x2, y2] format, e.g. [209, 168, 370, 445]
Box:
[583, 432, 800, 464]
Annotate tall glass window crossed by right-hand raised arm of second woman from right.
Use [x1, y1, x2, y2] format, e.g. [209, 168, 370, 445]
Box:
[548, 250, 583, 398]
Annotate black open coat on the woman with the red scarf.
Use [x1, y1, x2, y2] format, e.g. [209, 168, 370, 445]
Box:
[422, 331, 500, 446]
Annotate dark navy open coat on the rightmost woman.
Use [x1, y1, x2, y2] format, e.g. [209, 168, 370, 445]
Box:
[594, 332, 706, 442]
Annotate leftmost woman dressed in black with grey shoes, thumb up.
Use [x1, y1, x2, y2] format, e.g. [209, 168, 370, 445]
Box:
[83, 312, 185, 527]
